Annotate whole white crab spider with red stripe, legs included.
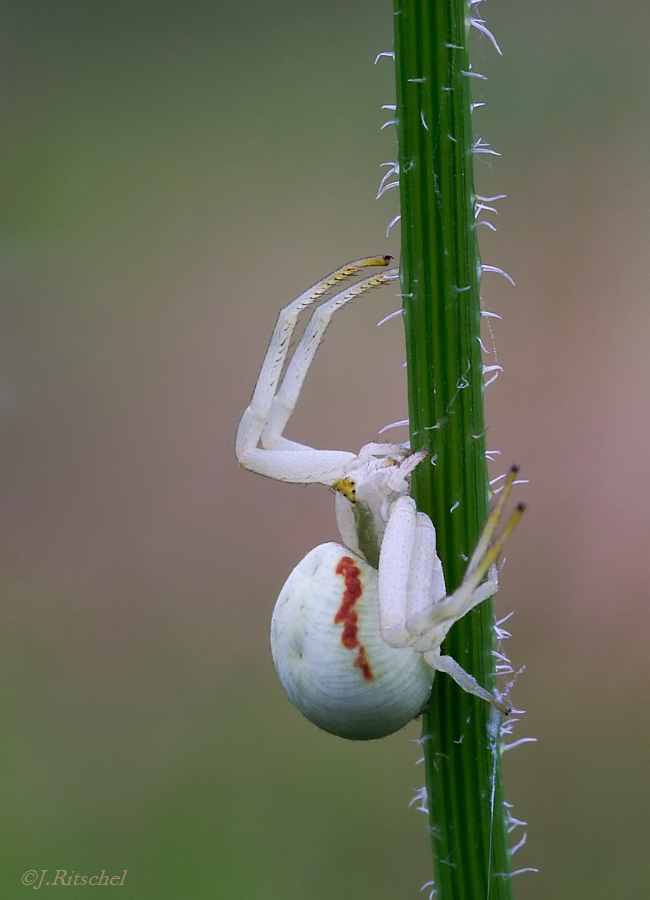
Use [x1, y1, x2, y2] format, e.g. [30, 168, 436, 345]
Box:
[236, 256, 521, 740]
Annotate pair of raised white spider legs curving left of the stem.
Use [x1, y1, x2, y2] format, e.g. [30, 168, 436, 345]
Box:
[235, 256, 397, 484]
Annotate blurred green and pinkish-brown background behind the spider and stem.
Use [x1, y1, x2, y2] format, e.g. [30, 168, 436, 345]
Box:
[0, 0, 650, 900]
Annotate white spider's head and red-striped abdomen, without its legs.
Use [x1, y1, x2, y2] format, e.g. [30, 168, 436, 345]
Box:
[271, 444, 436, 740]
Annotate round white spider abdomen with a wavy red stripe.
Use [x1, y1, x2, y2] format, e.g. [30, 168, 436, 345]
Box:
[271, 543, 433, 740]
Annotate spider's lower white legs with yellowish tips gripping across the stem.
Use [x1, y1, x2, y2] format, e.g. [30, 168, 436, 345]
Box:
[378, 467, 523, 713]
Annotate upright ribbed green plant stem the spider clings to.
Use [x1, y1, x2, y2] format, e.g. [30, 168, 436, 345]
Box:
[395, 0, 512, 900]
